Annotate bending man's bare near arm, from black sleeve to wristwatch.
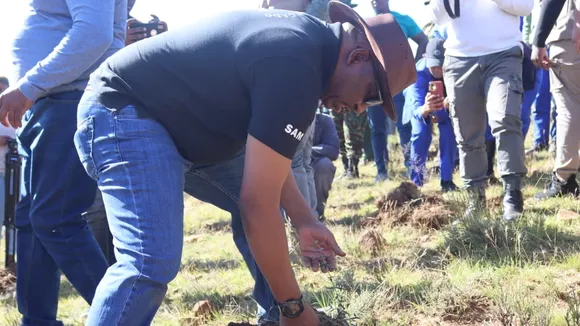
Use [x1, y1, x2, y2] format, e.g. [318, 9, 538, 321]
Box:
[240, 136, 304, 302]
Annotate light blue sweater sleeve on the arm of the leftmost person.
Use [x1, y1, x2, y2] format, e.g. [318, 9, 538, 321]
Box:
[16, 0, 115, 101]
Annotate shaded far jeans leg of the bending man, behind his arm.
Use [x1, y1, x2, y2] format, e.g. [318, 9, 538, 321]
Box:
[185, 152, 280, 322]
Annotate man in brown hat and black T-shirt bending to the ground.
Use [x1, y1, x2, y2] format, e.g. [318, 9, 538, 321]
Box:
[75, 5, 416, 326]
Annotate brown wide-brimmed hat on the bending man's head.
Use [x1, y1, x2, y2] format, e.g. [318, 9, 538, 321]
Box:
[328, 0, 417, 121]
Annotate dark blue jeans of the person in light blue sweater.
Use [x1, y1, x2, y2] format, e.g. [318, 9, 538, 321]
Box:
[16, 91, 107, 325]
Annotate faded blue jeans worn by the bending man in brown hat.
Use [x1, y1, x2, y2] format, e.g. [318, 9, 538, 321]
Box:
[75, 92, 273, 326]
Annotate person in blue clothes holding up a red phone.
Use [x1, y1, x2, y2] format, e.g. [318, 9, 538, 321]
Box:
[403, 38, 457, 192]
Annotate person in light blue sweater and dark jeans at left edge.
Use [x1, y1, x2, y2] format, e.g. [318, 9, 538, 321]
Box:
[0, 0, 127, 326]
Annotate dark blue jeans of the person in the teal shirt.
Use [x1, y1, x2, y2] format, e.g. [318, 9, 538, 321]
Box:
[367, 93, 411, 175]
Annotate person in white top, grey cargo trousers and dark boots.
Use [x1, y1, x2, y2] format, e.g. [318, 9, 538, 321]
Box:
[429, 0, 534, 220]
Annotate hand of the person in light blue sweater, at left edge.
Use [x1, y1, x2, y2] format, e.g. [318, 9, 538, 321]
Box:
[0, 87, 34, 128]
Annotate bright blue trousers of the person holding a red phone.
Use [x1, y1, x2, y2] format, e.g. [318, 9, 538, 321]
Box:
[411, 110, 458, 187]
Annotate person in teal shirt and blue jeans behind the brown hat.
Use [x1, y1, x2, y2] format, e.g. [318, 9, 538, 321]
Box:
[368, 0, 429, 182]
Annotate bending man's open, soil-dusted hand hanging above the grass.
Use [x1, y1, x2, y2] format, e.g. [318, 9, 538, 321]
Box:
[298, 221, 346, 273]
